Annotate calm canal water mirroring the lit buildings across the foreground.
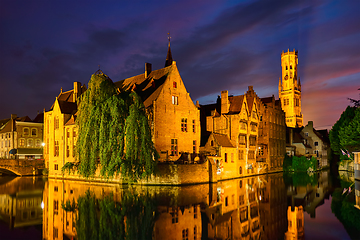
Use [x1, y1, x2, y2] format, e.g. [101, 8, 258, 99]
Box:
[0, 171, 360, 240]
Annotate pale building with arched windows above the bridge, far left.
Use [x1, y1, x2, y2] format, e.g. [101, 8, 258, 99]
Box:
[0, 114, 43, 159]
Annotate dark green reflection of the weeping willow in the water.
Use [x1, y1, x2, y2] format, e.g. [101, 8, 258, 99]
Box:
[76, 191, 156, 240]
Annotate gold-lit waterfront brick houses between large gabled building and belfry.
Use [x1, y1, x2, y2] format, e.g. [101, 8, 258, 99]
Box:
[201, 86, 286, 178]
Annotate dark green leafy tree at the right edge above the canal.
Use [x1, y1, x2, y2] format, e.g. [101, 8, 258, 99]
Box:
[329, 106, 360, 155]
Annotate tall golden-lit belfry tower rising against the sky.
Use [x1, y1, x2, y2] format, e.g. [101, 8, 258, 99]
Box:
[279, 49, 303, 127]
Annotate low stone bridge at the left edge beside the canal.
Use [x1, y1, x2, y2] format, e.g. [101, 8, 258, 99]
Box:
[0, 159, 45, 176]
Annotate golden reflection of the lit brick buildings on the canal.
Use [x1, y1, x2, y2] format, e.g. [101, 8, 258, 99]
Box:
[43, 174, 286, 240]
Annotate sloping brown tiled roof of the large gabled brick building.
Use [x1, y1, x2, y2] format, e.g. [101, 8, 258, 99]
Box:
[115, 66, 173, 107]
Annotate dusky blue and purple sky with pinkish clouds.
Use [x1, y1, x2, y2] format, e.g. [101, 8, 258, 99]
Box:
[0, 0, 360, 129]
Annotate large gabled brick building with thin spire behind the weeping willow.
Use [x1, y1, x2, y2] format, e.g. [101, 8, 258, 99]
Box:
[44, 45, 200, 176]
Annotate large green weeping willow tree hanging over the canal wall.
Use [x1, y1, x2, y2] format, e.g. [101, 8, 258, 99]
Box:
[76, 71, 158, 180]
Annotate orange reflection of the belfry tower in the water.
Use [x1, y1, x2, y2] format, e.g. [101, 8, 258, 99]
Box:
[285, 206, 304, 240]
